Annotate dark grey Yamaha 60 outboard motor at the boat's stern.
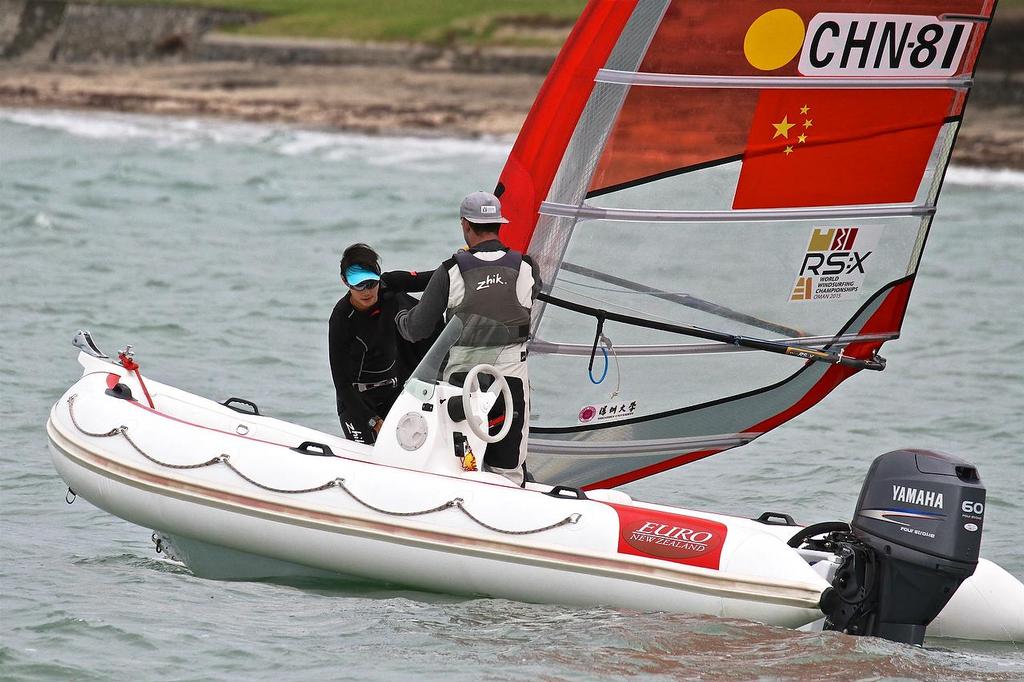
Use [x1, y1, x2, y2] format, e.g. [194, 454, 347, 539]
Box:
[808, 450, 985, 644]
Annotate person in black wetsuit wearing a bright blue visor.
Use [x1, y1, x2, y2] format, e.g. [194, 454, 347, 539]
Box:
[328, 244, 441, 444]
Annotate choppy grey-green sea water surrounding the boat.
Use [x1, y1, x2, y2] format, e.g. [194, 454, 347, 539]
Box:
[0, 110, 1024, 680]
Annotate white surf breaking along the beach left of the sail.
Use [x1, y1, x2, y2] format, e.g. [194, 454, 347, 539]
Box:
[0, 110, 510, 170]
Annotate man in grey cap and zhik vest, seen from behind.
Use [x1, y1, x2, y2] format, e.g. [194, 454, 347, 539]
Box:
[395, 191, 541, 484]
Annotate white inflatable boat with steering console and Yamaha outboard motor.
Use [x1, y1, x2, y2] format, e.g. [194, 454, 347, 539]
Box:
[46, 333, 1024, 642]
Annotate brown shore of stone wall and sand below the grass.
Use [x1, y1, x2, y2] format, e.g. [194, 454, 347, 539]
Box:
[0, 0, 1024, 170]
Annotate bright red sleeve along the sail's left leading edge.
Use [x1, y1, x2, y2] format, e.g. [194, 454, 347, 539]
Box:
[498, 0, 636, 251]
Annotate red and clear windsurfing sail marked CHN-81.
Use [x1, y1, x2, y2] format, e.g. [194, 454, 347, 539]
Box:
[496, 0, 994, 486]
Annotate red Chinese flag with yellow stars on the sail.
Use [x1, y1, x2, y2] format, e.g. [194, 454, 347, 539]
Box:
[732, 89, 954, 209]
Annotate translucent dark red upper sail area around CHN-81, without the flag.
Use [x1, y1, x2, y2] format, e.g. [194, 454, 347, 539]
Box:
[589, 0, 994, 195]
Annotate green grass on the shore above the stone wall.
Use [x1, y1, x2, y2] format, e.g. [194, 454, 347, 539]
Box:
[94, 0, 586, 47]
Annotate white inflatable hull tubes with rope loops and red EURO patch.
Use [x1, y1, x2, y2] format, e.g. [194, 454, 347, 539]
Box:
[47, 354, 1024, 640]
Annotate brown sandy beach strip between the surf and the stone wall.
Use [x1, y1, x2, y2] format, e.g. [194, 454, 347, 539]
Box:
[0, 61, 1024, 170]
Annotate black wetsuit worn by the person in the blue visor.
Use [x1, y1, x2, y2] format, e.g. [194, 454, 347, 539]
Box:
[328, 271, 436, 443]
